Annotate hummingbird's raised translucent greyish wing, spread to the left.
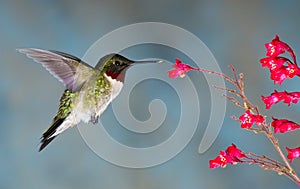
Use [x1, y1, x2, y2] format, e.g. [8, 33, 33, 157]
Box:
[17, 48, 95, 92]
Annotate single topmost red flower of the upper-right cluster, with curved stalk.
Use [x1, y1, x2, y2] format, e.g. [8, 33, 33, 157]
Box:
[265, 35, 296, 64]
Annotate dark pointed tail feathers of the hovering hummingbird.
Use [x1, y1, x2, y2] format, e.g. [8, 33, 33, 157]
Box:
[39, 118, 65, 152]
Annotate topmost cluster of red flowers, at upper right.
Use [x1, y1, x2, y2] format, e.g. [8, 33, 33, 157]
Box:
[260, 35, 300, 85]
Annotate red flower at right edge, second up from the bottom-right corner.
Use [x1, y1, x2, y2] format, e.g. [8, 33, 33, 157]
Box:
[271, 118, 300, 133]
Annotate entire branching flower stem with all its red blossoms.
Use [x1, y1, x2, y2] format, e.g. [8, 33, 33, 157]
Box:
[169, 35, 300, 186]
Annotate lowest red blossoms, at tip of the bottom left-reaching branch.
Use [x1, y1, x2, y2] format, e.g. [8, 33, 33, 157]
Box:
[209, 144, 247, 169]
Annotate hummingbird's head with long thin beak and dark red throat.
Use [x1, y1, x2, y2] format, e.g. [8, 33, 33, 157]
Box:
[95, 53, 162, 82]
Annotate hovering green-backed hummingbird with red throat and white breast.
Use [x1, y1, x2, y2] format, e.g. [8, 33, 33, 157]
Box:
[17, 48, 162, 151]
